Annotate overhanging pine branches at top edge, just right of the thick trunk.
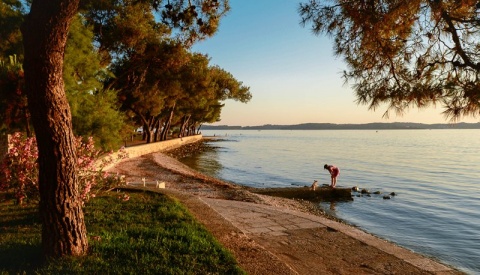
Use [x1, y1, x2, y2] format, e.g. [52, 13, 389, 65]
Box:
[80, 0, 230, 55]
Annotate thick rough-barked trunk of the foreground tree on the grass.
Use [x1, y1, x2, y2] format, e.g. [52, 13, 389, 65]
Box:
[22, 0, 88, 257]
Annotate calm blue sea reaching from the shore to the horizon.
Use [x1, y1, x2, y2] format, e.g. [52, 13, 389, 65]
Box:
[181, 129, 480, 274]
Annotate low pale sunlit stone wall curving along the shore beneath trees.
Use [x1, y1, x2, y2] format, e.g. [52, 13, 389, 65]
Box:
[102, 135, 203, 170]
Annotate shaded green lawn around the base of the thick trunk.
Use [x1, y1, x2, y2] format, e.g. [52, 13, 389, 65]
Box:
[0, 192, 244, 274]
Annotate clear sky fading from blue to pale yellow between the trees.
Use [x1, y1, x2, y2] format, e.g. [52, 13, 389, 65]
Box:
[193, 0, 479, 126]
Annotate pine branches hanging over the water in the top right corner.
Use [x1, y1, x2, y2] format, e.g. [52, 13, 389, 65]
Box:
[298, 0, 480, 120]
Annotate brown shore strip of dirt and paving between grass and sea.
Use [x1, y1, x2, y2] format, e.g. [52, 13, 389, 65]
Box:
[109, 143, 461, 274]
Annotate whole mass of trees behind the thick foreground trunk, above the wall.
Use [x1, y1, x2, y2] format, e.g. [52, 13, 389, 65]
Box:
[0, 0, 251, 150]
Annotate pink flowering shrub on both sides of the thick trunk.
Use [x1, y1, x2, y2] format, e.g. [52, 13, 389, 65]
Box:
[0, 133, 128, 204]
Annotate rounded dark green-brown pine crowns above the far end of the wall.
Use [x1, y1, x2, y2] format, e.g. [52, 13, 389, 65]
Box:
[111, 46, 252, 142]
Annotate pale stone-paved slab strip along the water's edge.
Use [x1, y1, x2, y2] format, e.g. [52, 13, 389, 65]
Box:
[201, 198, 455, 274]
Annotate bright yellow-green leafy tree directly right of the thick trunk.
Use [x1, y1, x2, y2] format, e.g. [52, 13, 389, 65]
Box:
[64, 15, 126, 150]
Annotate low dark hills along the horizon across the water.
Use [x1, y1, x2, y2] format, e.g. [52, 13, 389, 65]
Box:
[202, 122, 480, 130]
